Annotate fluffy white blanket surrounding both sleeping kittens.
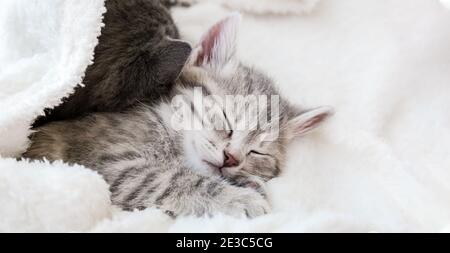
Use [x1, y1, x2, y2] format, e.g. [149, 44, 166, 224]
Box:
[0, 0, 450, 232]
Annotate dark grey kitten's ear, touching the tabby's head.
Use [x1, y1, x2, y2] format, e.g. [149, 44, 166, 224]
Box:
[153, 38, 192, 84]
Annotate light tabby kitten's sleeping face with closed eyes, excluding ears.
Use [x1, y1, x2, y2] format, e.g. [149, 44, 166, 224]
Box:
[184, 86, 284, 181]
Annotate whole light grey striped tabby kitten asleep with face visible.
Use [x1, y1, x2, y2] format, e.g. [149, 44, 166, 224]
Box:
[24, 15, 331, 217]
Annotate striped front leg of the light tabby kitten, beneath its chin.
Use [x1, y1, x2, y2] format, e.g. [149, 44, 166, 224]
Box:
[139, 168, 270, 218]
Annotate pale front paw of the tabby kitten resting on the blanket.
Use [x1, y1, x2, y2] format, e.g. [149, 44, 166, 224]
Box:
[224, 188, 270, 218]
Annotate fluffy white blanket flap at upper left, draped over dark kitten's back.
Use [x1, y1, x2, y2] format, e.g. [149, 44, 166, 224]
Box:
[0, 0, 105, 156]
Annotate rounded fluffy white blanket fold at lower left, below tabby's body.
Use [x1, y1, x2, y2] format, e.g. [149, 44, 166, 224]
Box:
[0, 159, 113, 233]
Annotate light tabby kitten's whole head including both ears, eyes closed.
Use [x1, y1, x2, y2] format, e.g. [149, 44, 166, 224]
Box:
[176, 14, 332, 181]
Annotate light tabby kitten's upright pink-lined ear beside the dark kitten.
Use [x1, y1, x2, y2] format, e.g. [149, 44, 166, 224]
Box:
[191, 13, 242, 70]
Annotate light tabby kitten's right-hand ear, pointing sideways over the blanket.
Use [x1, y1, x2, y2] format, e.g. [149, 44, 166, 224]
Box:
[287, 106, 334, 138]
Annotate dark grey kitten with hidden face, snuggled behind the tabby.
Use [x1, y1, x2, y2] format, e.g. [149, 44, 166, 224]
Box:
[34, 0, 192, 126]
